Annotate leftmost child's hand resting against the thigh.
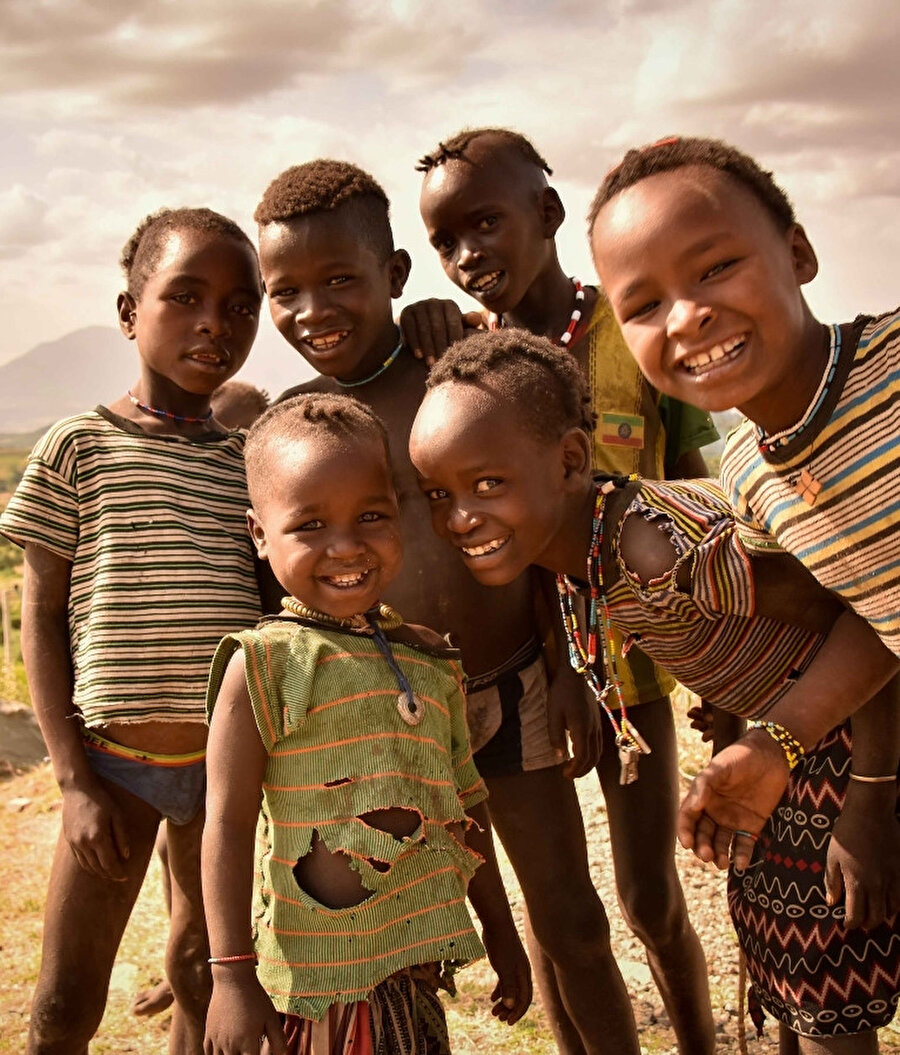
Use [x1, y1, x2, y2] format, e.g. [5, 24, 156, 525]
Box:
[62, 781, 131, 883]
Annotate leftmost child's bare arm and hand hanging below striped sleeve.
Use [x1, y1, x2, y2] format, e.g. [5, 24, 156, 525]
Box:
[22, 542, 130, 881]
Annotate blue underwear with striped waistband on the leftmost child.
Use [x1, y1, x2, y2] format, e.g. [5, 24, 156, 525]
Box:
[81, 729, 206, 825]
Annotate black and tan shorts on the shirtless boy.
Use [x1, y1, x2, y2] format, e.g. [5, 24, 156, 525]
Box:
[465, 640, 569, 778]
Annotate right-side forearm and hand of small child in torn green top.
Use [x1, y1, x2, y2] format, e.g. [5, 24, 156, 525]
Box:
[465, 802, 532, 1025]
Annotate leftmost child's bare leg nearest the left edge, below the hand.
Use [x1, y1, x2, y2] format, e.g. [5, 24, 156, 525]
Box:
[26, 781, 159, 1055]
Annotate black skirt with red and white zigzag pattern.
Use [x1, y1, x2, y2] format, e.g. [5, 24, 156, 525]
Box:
[728, 723, 900, 1037]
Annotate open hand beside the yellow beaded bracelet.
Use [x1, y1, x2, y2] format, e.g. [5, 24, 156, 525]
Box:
[677, 730, 790, 868]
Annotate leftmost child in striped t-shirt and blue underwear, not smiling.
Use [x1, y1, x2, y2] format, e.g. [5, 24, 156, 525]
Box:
[0, 201, 262, 1055]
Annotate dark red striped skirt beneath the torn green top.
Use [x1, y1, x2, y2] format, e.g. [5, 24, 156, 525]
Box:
[263, 963, 449, 1055]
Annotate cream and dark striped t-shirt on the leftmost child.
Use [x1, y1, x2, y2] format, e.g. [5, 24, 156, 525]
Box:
[0, 407, 260, 727]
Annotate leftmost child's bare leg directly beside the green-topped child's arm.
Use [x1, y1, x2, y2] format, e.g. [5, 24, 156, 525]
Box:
[166, 809, 209, 1055]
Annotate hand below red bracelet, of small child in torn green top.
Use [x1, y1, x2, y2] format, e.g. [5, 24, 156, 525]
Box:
[204, 963, 287, 1055]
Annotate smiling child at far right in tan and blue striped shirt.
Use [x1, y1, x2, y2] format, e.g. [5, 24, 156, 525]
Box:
[590, 138, 900, 855]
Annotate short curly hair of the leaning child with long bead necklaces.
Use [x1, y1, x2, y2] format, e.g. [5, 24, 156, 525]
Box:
[425, 327, 594, 442]
